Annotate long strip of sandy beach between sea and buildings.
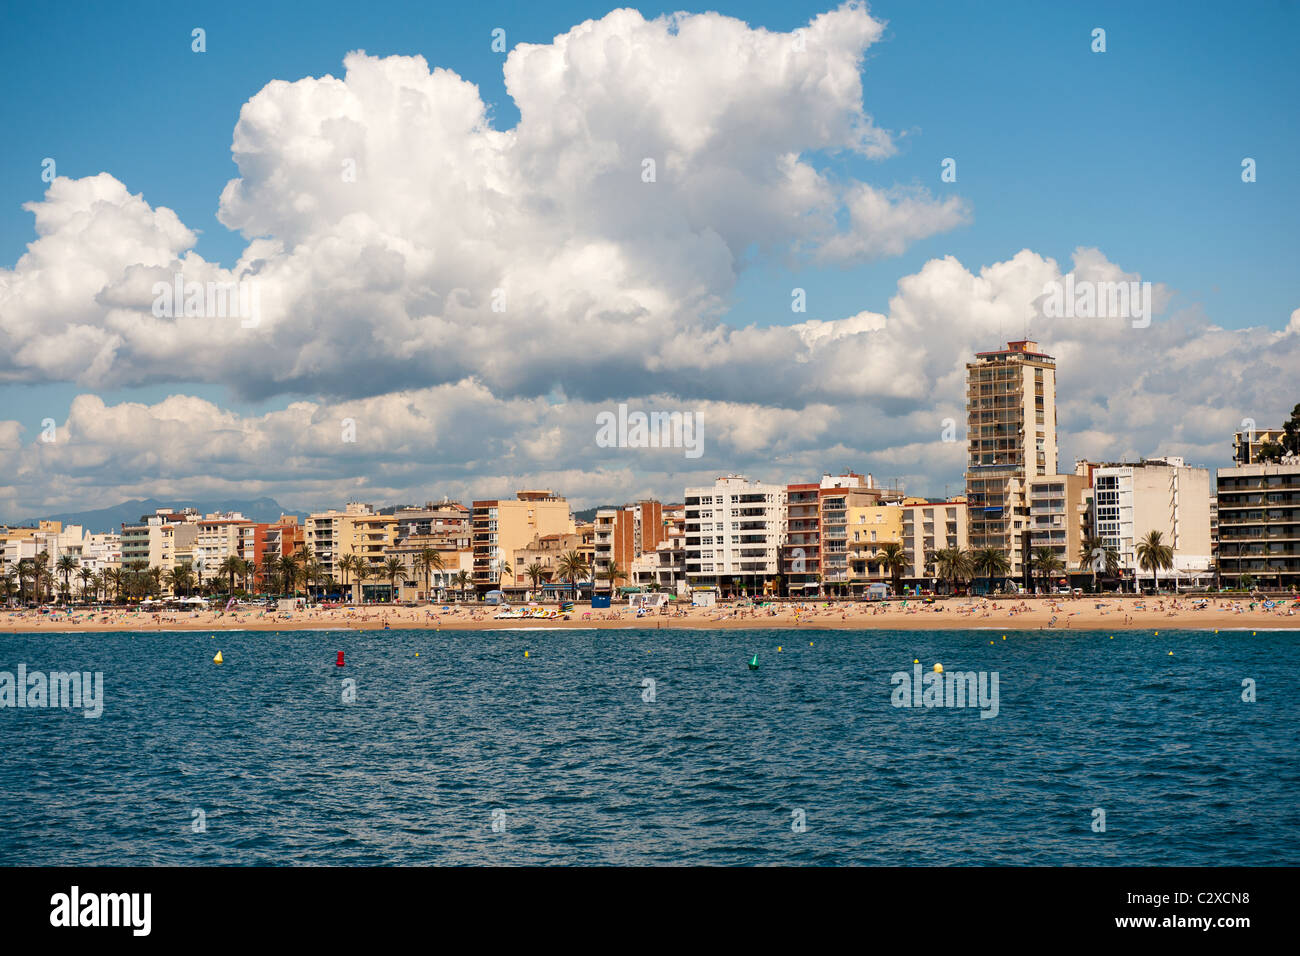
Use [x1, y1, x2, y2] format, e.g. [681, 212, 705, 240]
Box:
[0, 596, 1300, 633]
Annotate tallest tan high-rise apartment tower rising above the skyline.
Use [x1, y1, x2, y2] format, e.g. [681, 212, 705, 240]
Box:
[966, 341, 1057, 578]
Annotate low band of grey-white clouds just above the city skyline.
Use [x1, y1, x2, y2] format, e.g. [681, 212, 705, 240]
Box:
[0, 248, 1300, 516]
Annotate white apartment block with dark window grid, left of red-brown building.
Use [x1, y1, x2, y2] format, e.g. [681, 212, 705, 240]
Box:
[685, 475, 787, 594]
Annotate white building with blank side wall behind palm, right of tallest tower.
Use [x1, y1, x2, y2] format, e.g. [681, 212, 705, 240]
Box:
[1092, 457, 1210, 583]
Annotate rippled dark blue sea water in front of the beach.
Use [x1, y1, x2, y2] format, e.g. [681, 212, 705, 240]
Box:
[0, 630, 1300, 866]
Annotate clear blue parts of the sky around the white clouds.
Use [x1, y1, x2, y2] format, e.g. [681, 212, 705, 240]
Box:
[0, 0, 1300, 515]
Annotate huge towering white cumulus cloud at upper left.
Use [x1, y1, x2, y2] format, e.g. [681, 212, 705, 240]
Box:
[0, 4, 967, 399]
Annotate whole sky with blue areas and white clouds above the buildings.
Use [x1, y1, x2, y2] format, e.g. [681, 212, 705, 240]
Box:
[0, 0, 1300, 519]
